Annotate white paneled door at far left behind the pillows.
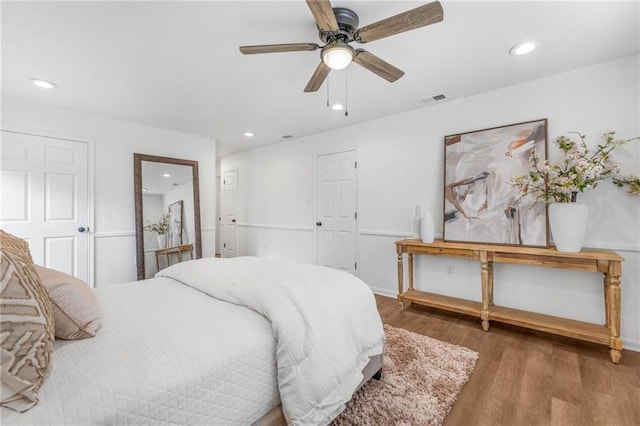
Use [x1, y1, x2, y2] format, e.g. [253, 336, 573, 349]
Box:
[0, 130, 89, 282]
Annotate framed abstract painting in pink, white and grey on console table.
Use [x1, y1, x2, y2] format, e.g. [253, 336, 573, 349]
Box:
[442, 118, 549, 247]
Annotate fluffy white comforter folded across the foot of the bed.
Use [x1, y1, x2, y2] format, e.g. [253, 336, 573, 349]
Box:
[157, 257, 384, 425]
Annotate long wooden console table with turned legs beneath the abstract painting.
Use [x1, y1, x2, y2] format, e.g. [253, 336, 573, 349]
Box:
[395, 240, 624, 364]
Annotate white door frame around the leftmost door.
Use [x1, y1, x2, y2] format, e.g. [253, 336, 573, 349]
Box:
[0, 124, 95, 287]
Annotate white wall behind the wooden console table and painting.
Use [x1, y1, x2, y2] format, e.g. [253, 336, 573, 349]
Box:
[220, 56, 640, 350]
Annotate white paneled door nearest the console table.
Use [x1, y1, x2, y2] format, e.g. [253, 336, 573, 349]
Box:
[316, 151, 357, 273]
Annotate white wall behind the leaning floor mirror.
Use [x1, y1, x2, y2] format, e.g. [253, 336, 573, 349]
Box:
[2, 95, 216, 286]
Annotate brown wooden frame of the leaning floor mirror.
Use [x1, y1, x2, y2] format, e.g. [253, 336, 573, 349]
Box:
[133, 153, 202, 280]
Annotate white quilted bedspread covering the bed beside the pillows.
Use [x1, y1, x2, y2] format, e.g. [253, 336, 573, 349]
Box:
[0, 278, 279, 426]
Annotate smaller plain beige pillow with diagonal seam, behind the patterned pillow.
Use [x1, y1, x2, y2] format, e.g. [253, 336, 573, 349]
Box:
[35, 265, 100, 340]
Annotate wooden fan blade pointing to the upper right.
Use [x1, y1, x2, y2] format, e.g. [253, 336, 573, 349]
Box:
[353, 1, 444, 43]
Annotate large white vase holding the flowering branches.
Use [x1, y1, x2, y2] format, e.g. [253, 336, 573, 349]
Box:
[549, 203, 589, 253]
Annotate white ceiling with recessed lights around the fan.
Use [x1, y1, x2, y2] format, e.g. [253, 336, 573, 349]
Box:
[1, 0, 640, 156]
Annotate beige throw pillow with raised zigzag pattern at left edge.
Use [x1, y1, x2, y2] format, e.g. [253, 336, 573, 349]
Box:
[0, 245, 54, 412]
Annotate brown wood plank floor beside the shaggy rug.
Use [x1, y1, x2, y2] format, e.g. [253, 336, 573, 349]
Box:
[376, 295, 640, 426]
